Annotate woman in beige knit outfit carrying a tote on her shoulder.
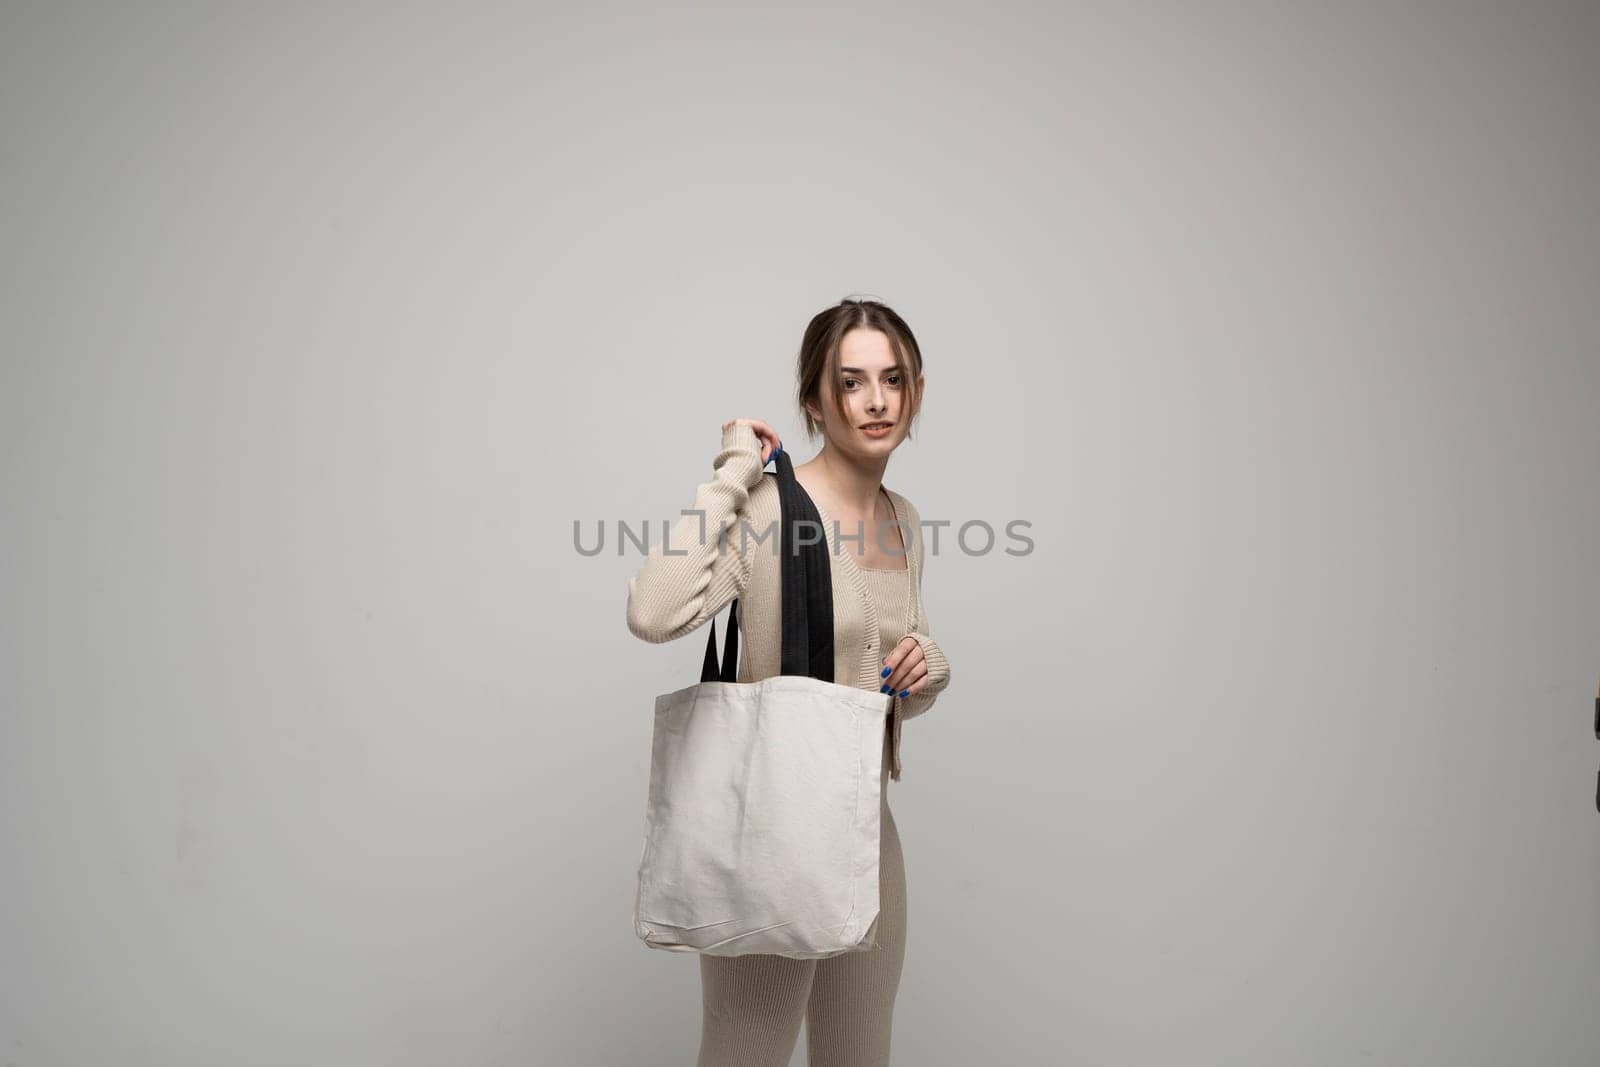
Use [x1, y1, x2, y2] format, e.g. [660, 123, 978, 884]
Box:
[627, 299, 950, 1067]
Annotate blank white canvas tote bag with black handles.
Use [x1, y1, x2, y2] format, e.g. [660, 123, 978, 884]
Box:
[634, 453, 891, 960]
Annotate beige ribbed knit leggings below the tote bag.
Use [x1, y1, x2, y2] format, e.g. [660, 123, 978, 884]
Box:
[699, 793, 906, 1067]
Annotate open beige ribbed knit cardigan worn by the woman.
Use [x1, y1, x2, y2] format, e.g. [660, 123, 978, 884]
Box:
[627, 422, 950, 781]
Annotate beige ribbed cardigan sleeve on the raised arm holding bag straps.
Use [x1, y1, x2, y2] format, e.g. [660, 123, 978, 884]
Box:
[627, 422, 763, 645]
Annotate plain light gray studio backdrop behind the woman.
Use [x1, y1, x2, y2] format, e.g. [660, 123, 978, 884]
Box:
[0, 3, 1600, 1067]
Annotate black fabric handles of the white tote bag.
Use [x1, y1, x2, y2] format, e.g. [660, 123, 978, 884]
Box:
[701, 451, 834, 681]
